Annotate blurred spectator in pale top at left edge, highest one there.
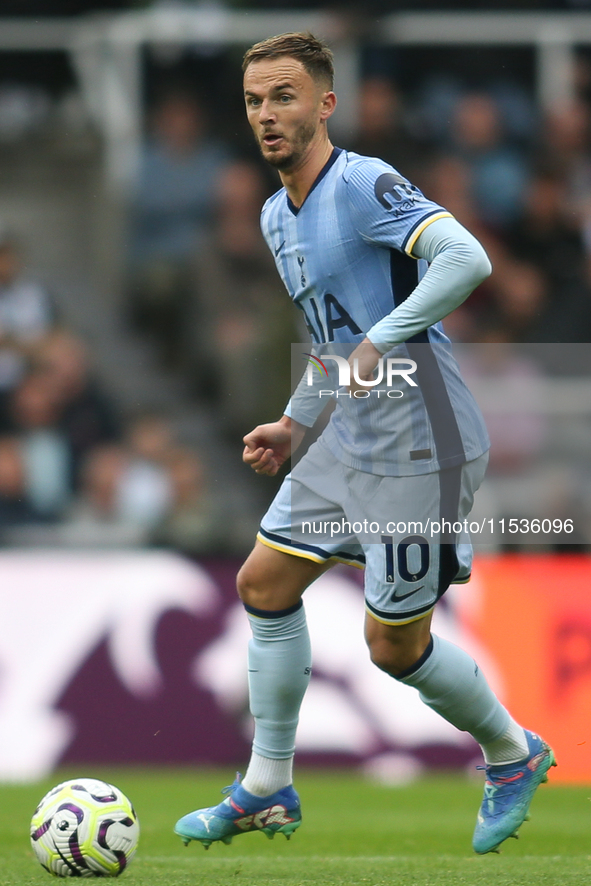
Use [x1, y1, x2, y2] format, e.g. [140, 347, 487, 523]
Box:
[0, 229, 55, 392]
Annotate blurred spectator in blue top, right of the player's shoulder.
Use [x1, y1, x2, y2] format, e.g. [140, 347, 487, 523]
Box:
[451, 92, 527, 227]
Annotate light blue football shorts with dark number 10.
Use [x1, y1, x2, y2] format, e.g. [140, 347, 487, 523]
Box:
[257, 439, 488, 624]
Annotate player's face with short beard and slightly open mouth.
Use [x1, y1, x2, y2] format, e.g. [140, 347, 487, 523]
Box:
[244, 56, 328, 170]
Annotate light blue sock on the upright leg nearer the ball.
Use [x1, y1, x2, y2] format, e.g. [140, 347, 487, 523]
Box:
[246, 603, 312, 760]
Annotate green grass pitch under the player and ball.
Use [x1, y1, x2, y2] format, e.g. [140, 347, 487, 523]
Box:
[0, 768, 591, 886]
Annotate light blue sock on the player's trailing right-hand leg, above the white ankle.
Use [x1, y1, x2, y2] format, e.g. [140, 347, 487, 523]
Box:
[397, 634, 511, 745]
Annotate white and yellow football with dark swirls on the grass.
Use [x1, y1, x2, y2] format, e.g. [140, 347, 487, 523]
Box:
[31, 778, 140, 877]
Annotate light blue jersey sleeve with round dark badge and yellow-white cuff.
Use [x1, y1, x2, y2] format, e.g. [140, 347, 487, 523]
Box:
[344, 158, 452, 257]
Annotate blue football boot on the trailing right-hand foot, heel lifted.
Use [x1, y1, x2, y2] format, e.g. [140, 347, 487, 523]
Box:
[472, 730, 556, 855]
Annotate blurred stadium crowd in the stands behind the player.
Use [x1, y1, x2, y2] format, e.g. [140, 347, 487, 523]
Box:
[0, 4, 591, 555]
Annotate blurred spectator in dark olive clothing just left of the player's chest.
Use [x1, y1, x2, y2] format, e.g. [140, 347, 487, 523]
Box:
[187, 161, 300, 439]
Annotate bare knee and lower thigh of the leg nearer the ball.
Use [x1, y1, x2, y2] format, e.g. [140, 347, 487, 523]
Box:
[237, 541, 334, 612]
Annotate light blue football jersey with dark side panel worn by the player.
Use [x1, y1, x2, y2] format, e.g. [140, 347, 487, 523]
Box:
[261, 148, 489, 476]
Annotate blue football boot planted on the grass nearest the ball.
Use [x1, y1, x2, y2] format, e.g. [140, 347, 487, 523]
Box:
[174, 772, 302, 849]
